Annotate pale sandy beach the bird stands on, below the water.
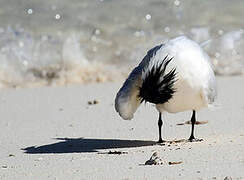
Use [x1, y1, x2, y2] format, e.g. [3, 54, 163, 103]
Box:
[0, 77, 244, 180]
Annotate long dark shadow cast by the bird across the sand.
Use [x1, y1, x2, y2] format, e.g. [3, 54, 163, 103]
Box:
[22, 138, 156, 154]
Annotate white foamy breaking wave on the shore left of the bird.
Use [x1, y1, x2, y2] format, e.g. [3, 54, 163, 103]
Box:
[0, 27, 124, 88]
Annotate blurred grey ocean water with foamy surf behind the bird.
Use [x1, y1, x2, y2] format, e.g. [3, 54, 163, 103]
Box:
[0, 0, 244, 88]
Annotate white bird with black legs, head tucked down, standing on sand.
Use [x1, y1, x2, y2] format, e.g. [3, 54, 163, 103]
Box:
[115, 36, 217, 143]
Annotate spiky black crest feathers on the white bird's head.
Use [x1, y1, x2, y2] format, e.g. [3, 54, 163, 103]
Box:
[139, 56, 176, 104]
